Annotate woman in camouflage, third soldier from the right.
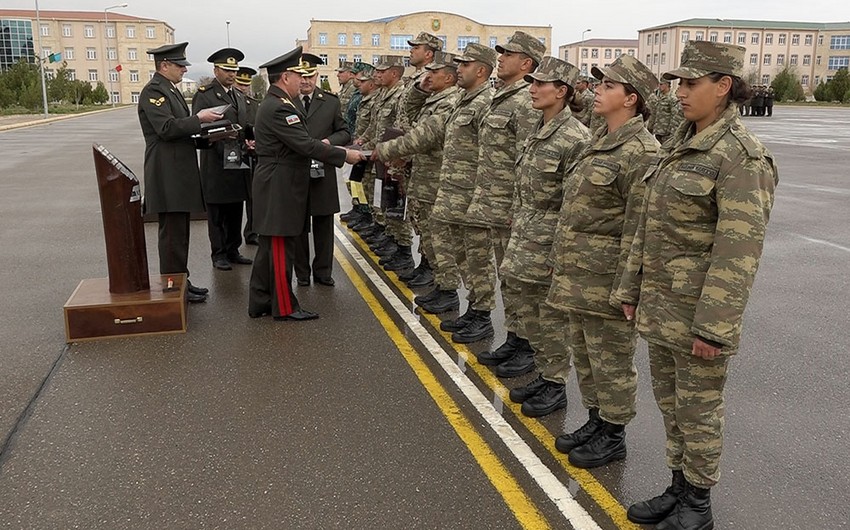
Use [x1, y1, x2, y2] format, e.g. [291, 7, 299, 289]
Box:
[496, 57, 588, 416]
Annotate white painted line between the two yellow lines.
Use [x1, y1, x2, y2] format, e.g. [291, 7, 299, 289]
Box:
[334, 226, 600, 530]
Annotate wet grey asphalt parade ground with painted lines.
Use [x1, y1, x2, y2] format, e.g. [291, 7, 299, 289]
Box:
[0, 107, 850, 530]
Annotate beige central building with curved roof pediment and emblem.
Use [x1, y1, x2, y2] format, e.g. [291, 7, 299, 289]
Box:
[298, 11, 552, 90]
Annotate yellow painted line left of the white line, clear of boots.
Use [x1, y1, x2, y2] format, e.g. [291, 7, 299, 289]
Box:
[335, 249, 551, 529]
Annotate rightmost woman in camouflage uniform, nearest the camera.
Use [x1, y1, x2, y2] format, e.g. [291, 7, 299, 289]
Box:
[616, 41, 778, 530]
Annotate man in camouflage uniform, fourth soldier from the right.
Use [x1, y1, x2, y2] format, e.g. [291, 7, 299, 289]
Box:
[440, 31, 546, 342]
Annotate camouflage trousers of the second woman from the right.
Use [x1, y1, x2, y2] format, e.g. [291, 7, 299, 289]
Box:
[567, 311, 637, 425]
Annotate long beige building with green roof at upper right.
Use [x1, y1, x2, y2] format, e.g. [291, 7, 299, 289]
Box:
[638, 18, 850, 94]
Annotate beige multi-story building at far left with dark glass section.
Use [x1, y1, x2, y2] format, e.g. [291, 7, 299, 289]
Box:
[0, 9, 174, 103]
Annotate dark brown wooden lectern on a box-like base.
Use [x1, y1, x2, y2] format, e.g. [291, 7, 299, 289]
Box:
[64, 145, 186, 342]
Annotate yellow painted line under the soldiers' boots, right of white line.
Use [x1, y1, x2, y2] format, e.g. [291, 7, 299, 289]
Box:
[348, 226, 642, 530]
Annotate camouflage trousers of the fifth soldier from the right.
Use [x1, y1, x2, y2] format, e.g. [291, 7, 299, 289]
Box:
[463, 226, 498, 311]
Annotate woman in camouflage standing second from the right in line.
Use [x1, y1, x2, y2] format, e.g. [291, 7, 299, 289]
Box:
[547, 55, 658, 468]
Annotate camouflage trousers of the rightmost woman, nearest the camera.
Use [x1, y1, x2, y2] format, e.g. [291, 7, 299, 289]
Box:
[649, 343, 730, 488]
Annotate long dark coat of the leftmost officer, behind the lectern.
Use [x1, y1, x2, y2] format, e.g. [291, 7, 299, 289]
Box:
[138, 73, 204, 213]
